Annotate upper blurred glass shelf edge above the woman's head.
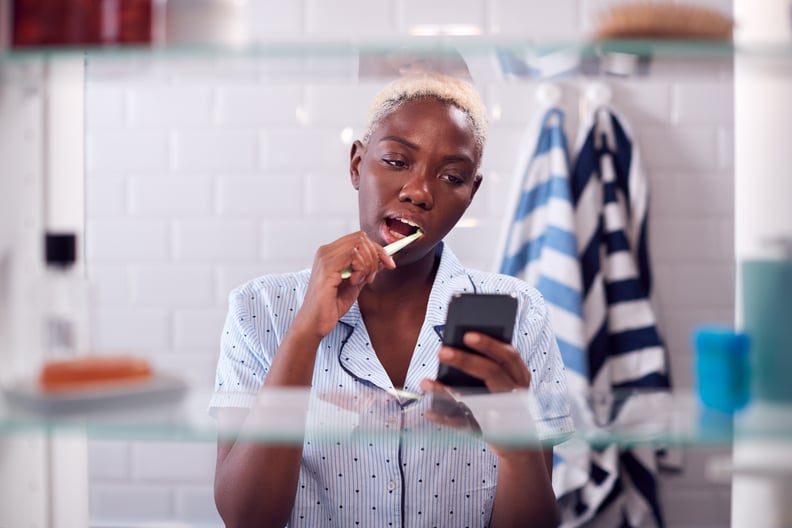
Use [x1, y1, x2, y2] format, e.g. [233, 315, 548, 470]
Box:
[0, 36, 752, 87]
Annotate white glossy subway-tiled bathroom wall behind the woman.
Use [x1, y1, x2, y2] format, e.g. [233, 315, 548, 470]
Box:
[85, 0, 734, 527]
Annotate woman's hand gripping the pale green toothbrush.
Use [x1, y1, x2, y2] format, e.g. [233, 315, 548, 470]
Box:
[294, 231, 396, 337]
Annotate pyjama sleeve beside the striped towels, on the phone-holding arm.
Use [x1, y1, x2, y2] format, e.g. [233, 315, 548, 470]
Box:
[514, 287, 575, 444]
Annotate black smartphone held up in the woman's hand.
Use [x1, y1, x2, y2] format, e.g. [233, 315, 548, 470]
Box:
[437, 293, 517, 392]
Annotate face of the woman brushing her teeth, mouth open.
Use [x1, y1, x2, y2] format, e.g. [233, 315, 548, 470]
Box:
[350, 98, 481, 263]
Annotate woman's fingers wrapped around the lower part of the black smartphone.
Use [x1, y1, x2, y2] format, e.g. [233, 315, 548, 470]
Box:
[438, 332, 531, 392]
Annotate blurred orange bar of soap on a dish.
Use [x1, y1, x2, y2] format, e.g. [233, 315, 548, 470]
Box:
[39, 356, 153, 392]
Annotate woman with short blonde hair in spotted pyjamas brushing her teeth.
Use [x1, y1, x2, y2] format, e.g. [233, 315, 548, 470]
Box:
[212, 75, 571, 527]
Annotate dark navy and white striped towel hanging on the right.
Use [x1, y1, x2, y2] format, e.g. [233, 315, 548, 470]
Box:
[562, 107, 670, 526]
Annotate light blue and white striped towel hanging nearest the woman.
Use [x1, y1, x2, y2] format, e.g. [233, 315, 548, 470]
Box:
[500, 108, 590, 508]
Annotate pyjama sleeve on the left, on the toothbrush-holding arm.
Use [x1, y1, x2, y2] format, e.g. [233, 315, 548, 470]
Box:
[209, 289, 271, 416]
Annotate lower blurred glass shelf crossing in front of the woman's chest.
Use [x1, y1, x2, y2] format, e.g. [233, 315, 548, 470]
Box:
[0, 389, 792, 446]
